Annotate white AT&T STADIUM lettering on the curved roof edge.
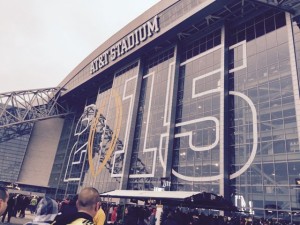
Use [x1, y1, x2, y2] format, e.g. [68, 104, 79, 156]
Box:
[90, 16, 160, 74]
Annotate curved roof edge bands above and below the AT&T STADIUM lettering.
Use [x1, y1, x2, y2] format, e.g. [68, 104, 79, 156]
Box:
[59, 0, 300, 94]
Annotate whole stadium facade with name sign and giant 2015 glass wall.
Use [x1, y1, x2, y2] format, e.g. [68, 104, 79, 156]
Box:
[0, 0, 300, 219]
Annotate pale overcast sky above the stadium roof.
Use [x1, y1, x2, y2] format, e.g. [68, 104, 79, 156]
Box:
[0, 0, 159, 93]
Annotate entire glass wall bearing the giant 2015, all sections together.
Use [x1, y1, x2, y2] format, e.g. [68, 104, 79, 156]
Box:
[49, 7, 300, 219]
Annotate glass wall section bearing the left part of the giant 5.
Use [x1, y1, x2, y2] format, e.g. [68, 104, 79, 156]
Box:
[172, 30, 223, 194]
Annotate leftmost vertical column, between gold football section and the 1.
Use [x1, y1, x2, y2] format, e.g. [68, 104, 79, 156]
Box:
[120, 58, 144, 190]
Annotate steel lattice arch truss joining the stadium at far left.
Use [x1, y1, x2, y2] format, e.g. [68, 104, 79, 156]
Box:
[0, 87, 71, 142]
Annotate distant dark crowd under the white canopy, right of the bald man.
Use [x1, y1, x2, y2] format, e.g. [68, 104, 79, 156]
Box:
[95, 205, 300, 225]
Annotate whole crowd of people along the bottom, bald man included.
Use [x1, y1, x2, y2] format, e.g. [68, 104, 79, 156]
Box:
[0, 187, 297, 225]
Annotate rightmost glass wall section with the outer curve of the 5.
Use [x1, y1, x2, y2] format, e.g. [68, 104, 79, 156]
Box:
[229, 11, 300, 218]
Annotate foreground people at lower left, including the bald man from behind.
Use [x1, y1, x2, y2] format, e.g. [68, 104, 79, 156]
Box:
[0, 187, 106, 225]
